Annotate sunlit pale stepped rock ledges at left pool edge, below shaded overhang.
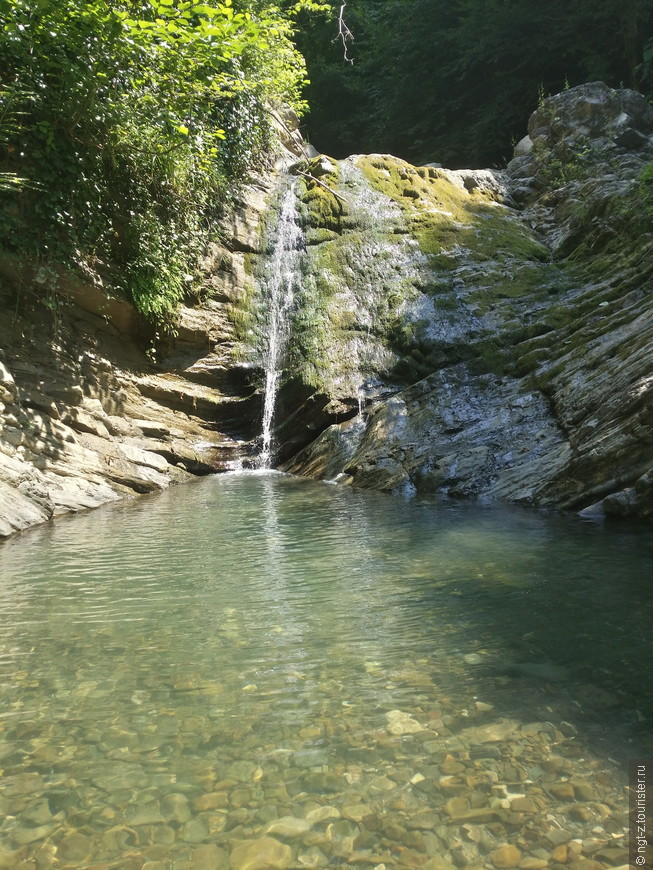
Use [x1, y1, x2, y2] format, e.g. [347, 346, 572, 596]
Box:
[0, 292, 252, 536]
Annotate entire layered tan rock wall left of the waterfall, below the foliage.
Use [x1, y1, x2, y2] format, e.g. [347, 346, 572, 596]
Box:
[0, 171, 282, 537]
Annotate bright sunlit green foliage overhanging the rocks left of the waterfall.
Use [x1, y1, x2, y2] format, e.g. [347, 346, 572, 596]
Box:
[0, 0, 317, 326]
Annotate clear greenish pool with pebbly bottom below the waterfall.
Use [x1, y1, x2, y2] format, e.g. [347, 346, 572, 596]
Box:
[0, 473, 653, 870]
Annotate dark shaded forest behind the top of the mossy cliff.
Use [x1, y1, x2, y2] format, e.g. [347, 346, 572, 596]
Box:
[298, 0, 653, 168]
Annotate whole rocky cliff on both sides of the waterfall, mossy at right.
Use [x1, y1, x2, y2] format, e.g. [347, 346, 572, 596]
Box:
[0, 83, 653, 536]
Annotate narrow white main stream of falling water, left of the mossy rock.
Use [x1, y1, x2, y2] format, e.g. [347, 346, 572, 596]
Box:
[258, 179, 304, 468]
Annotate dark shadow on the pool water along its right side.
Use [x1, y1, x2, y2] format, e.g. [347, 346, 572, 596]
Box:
[390, 507, 653, 765]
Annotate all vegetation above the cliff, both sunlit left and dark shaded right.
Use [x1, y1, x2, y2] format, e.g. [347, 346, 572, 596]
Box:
[0, 0, 653, 328]
